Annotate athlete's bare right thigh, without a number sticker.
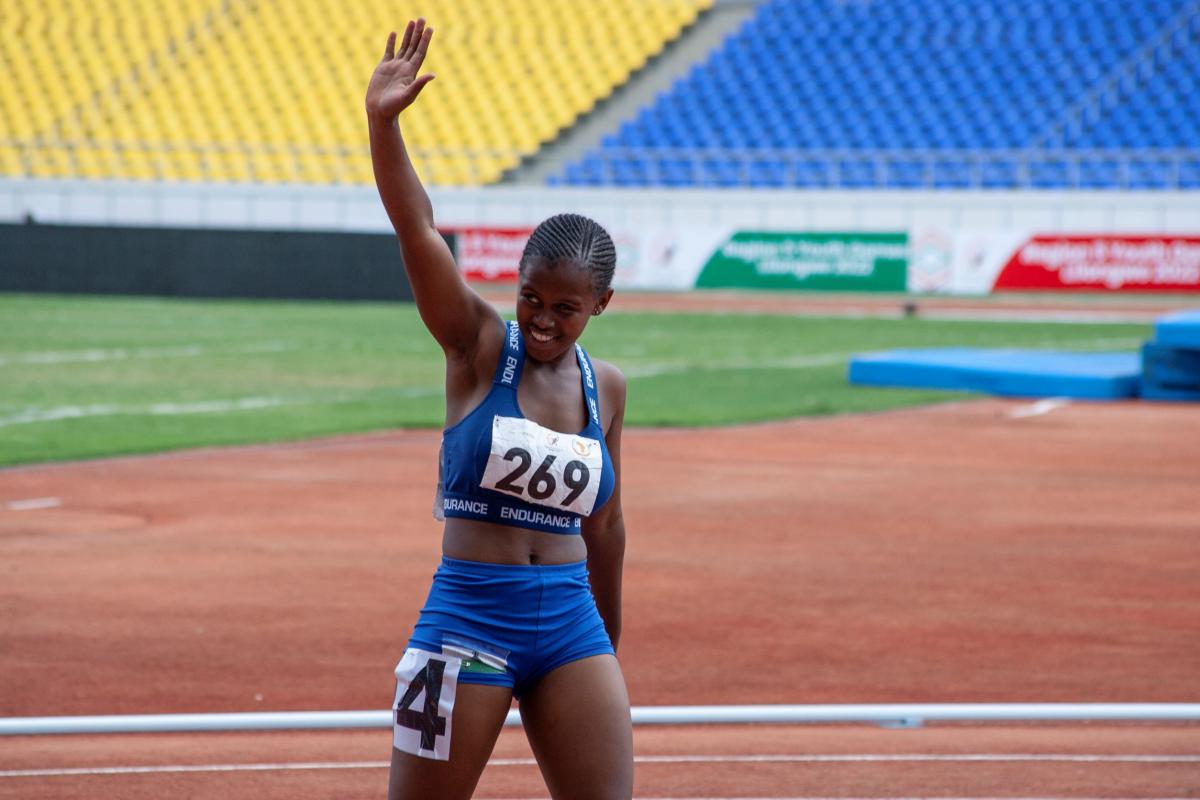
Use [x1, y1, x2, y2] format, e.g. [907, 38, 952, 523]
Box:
[521, 655, 634, 800]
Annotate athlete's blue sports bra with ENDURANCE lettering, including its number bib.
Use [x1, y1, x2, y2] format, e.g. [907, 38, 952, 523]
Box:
[434, 321, 616, 534]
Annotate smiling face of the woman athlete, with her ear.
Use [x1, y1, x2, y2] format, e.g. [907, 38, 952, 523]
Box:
[517, 259, 612, 361]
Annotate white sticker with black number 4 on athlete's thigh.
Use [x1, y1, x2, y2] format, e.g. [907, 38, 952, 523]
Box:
[391, 648, 462, 762]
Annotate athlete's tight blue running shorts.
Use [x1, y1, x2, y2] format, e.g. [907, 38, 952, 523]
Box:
[408, 557, 614, 699]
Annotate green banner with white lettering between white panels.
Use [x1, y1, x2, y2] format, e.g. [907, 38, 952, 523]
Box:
[696, 230, 908, 291]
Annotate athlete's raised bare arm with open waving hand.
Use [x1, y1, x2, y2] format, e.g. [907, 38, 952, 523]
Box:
[366, 19, 499, 357]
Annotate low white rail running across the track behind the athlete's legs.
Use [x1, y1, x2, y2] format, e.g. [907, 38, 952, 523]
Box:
[0, 703, 1200, 736]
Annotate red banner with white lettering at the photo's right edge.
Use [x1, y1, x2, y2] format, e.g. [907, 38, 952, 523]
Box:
[995, 235, 1200, 291]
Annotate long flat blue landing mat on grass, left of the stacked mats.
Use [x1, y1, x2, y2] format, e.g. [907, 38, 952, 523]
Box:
[850, 348, 1141, 399]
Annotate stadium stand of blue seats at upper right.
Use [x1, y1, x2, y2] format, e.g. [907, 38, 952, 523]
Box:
[550, 0, 1200, 188]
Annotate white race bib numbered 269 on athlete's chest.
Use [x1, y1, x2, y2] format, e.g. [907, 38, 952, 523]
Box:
[480, 415, 604, 516]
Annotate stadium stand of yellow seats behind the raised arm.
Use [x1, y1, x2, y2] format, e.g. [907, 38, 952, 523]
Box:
[0, 0, 712, 185]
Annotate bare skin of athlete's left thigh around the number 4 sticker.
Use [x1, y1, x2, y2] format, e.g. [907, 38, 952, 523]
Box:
[388, 684, 512, 800]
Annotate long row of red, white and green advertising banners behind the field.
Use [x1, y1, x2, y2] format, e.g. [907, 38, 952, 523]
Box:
[444, 224, 1200, 295]
